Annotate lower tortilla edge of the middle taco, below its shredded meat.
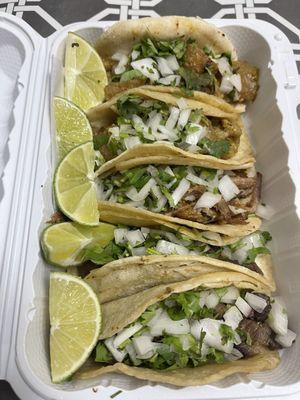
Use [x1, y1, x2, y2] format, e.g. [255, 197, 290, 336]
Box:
[98, 201, 261, 246]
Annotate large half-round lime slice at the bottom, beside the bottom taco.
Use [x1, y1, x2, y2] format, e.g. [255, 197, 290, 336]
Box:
[49, 272, 101, 383]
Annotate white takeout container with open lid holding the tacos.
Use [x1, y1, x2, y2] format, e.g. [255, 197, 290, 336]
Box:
[0, 13, 300, 400]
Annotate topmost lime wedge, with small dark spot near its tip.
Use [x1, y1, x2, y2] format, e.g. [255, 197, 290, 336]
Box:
[65, 32, 107, 111]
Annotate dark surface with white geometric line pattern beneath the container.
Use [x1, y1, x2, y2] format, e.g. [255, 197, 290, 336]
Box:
[0, 0, 300, 400]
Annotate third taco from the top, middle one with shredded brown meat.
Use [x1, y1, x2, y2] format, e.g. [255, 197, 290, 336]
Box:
[96, 165, 261, 244]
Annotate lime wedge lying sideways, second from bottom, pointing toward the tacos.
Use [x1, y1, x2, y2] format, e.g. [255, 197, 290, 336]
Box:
[41, 222, 115, 267]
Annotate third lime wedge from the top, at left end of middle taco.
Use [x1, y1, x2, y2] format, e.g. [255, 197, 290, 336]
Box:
[54, 142, 99, 225]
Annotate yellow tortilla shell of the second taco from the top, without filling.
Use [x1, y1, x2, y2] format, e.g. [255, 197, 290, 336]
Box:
[87, 86, 255, 175]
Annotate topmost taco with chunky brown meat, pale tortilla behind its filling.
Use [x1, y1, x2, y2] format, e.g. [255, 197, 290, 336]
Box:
[97, 16, 259, 103]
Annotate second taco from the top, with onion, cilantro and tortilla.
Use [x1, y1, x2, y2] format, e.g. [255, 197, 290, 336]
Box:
[88, 86, 255, 174]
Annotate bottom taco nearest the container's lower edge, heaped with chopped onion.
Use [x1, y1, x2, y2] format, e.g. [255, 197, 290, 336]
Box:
[75, 263, 296, 386]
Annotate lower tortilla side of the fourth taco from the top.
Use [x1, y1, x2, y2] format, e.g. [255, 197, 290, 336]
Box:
[85, 254, 276, 303]
